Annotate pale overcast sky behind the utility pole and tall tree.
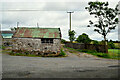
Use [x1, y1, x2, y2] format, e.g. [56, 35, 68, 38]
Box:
[0, 0, 119, 41]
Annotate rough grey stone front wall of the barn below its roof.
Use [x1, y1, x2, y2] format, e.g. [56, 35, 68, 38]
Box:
[12, 38, 61, 54]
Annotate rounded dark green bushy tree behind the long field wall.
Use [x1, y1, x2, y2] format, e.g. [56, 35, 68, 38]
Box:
[76, 33, 91, 44]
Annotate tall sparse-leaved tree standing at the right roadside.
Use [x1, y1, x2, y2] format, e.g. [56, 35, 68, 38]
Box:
[85, 1, 119, 53]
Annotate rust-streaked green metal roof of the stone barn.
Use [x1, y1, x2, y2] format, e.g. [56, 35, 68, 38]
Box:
[13, 27, 61, 38]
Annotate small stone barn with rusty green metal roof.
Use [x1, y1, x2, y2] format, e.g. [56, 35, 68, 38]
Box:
[12, 27, 61, 55]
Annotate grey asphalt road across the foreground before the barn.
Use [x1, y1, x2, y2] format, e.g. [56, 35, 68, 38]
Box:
[2, 48, 119, 78]
